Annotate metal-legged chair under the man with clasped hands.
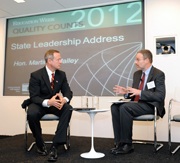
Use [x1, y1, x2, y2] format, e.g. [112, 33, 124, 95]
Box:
[21, 99, 70, 152]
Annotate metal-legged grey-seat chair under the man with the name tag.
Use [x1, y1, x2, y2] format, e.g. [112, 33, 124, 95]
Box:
[133, 107, 163, 152]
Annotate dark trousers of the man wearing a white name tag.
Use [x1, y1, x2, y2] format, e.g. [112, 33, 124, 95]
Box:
[111, 103, 154, 143]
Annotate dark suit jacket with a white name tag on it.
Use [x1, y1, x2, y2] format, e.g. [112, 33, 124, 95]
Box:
[132, 66, 166, 117]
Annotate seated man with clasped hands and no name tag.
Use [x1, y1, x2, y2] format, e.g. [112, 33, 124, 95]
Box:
[27, 50, 73, 161]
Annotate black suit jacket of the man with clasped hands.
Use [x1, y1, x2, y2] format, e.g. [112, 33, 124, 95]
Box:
[29, 67, 72, 106]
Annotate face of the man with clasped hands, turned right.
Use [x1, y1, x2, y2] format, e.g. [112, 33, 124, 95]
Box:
[50, 53, 62, 71]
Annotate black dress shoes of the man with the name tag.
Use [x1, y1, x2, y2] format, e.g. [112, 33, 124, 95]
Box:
[112, 144, 134, 155]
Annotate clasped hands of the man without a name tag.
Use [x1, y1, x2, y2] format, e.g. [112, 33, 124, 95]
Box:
[48, 93, 66, 110]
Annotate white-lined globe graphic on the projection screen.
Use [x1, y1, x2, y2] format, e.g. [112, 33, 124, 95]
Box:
[69, 42, 142, 96]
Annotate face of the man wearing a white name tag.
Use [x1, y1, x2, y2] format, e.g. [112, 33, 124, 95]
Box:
[134, 53, 147, 70]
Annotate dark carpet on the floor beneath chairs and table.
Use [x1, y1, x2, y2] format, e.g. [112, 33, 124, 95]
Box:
[0, 135, 180, 163]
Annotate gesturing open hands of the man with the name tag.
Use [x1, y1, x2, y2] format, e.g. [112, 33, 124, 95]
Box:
[113, 85, 141, 97]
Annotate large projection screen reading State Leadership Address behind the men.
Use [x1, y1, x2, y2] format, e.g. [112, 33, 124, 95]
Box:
[3, 1, 144, 96]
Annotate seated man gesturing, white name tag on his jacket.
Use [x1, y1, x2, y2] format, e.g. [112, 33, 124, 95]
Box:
[111, 49, 166, 155]
